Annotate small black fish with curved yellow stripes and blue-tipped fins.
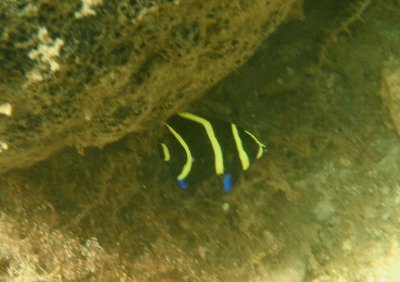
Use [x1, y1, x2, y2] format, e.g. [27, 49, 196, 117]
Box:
[160, 112, 266, 192]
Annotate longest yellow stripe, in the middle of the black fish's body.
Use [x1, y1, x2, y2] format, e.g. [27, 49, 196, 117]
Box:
[179, 112, 224, 175]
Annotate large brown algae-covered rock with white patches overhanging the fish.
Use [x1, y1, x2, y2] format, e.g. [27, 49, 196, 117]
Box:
[0, 0, 301, 173]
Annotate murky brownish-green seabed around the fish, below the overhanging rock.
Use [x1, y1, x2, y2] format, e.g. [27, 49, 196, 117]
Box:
[0, 0, 400, 282]
